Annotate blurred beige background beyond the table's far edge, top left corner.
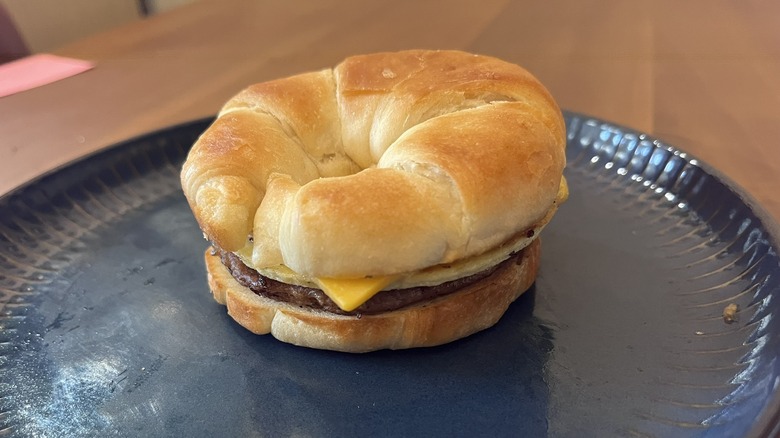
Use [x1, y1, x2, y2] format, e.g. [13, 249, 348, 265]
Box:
[0, 0, 197, 63]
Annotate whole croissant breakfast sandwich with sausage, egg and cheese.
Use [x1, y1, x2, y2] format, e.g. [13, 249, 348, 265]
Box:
[181, 50, 567, 352]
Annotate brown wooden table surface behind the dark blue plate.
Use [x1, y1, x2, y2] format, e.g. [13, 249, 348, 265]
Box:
[0, 0, 780, 219]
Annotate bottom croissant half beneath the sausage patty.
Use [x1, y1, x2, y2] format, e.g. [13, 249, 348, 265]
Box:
[205, 239, 540, 353]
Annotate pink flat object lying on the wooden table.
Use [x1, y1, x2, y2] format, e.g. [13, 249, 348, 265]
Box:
[0, 54, 95, 97]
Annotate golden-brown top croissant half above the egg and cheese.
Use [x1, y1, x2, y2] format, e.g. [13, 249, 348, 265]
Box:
[182, 50, 565, 277]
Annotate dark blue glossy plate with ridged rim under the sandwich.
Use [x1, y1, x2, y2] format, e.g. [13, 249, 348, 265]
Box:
[0, 113, 780, 437]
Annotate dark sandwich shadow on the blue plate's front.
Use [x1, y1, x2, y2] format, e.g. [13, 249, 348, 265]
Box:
[232, 287, 553, 436]
